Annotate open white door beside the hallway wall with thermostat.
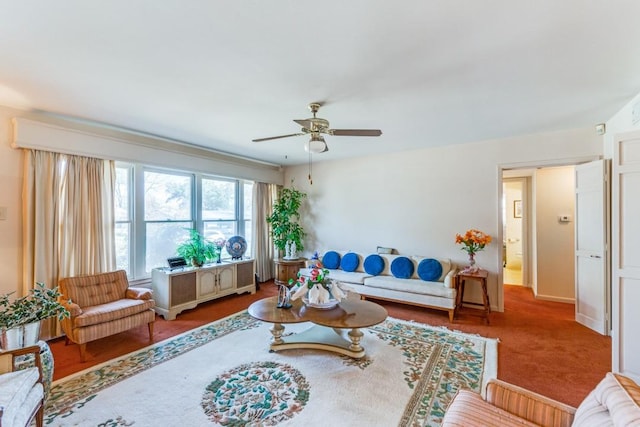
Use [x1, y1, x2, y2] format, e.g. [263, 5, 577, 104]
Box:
[576, 160, 610, 335]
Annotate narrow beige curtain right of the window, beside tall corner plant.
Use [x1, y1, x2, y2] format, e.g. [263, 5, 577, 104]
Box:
[252, 182, 278, 282]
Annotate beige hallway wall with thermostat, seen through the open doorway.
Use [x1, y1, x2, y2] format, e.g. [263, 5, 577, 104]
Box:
[534, 166, 575, 302]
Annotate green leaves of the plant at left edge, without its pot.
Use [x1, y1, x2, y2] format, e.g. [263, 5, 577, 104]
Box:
[0, 282, 69, 329]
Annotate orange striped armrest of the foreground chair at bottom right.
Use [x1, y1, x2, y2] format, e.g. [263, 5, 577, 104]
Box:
[485, 379, 576, 427]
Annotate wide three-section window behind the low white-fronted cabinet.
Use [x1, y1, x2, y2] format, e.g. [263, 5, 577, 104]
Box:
[115, 163, 253, 279]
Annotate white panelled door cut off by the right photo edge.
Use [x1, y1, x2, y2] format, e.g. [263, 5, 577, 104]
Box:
[611, 132, 640, 382]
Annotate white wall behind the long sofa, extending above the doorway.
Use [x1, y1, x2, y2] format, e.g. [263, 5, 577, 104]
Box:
[285, 128, 602, 308]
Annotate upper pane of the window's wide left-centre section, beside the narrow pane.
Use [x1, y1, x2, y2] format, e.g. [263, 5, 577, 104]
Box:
[144, 171, 192, 221]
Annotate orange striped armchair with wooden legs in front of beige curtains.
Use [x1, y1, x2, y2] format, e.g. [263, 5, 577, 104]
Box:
[60, 270, 155, 362]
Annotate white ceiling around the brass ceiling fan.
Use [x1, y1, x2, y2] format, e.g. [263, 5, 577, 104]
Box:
[0, 0, 640, 165]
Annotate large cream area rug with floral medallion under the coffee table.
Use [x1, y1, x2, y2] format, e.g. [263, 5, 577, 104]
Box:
[45, 312, 497, 427]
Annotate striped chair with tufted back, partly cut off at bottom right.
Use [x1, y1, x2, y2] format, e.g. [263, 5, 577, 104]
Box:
[442, 372, 640, 427]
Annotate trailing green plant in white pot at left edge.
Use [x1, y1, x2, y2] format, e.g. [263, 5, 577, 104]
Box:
[0, 282, 69, 350]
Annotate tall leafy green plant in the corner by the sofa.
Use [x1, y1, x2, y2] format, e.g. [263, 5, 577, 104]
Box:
[267, 188, 307, 259]
